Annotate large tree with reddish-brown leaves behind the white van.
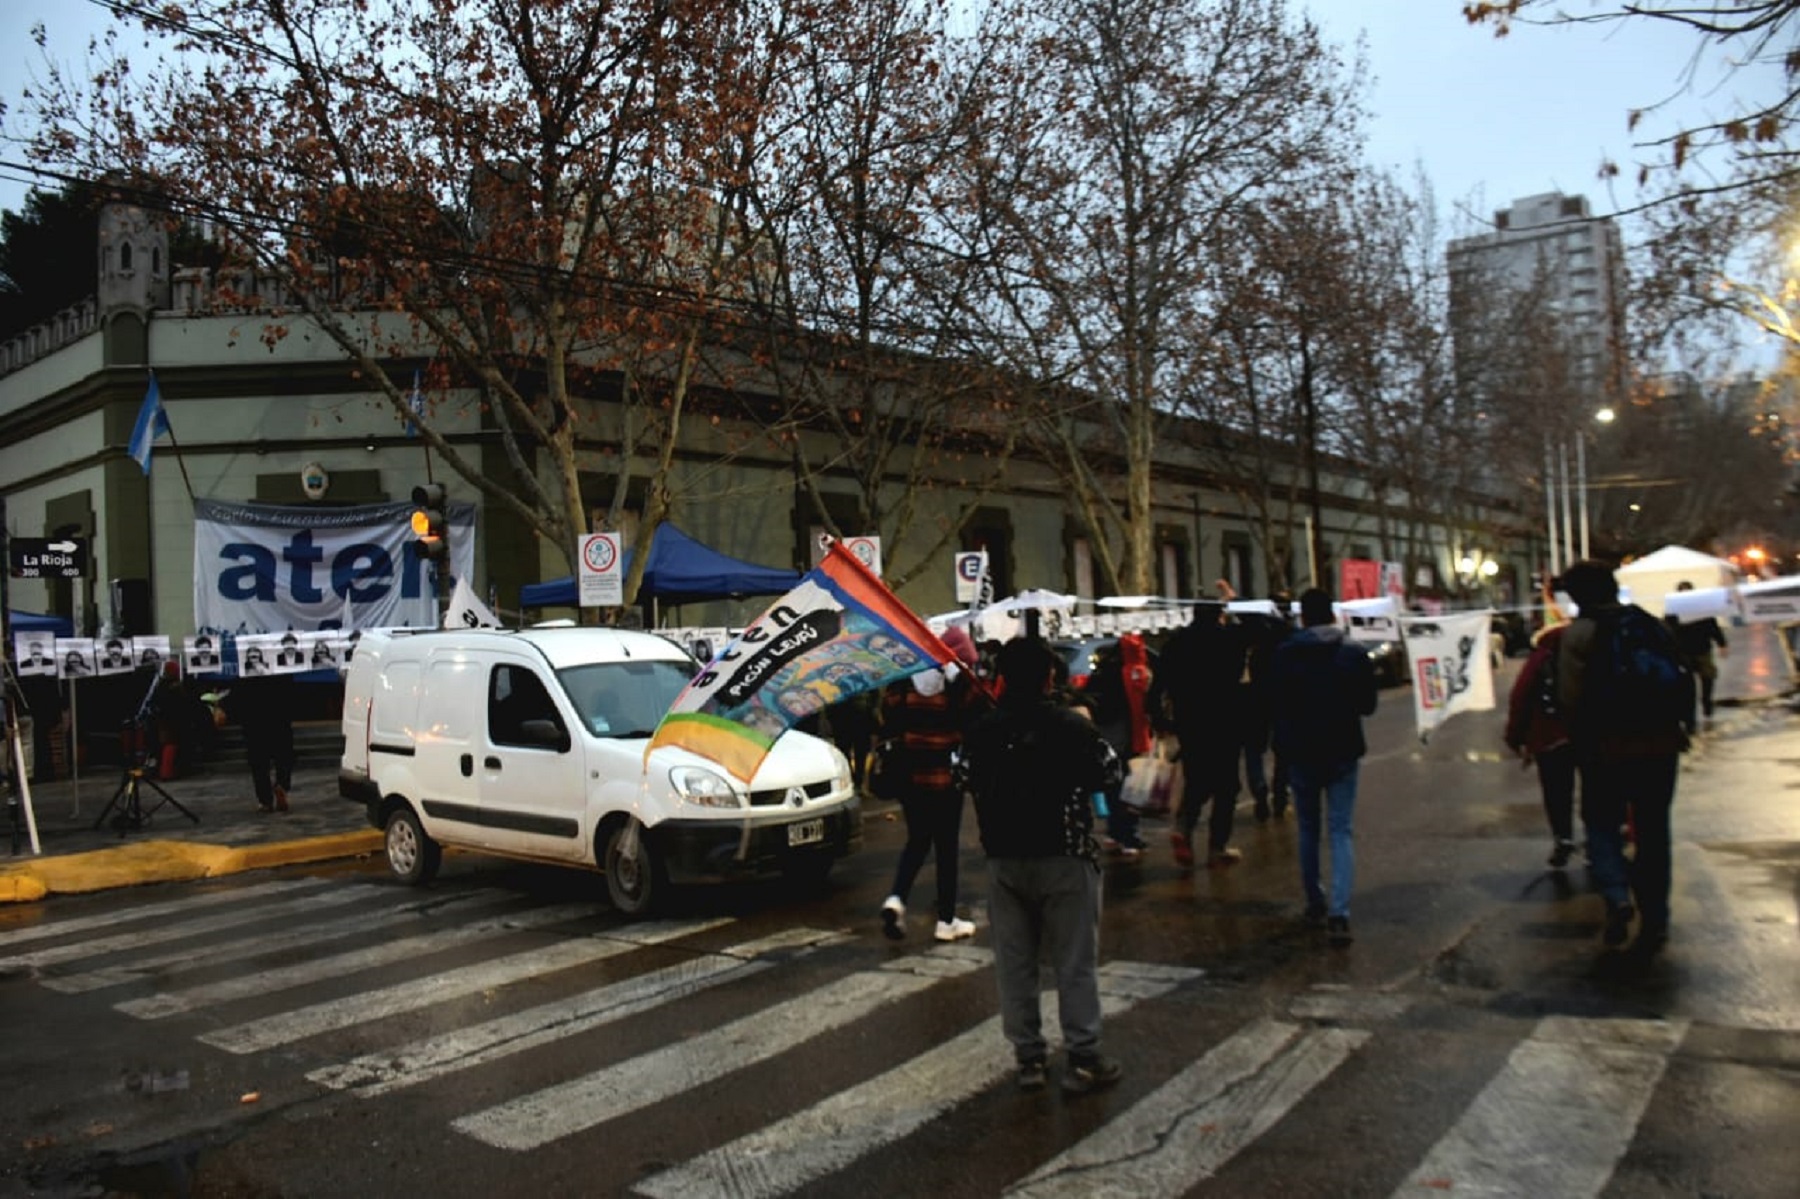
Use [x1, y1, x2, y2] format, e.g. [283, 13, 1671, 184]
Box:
[12, 0, 885, 601]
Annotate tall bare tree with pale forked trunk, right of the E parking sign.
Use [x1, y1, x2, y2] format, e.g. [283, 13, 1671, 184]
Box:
[963, 0, 1357, 590]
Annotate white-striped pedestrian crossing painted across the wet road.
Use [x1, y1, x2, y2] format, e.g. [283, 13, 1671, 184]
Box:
[0, 879, 1742, 1199]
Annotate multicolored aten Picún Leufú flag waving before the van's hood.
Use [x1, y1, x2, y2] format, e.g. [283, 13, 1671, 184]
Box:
[644, 542, 956, 781]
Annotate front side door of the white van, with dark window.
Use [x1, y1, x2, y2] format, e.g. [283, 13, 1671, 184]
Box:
[477, 659, 589, 861]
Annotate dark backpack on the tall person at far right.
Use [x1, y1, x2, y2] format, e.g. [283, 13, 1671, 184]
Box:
[1582, 603, 1694, 736]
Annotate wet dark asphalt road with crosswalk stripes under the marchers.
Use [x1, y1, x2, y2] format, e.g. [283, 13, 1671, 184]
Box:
[0, 630, 1800, 1195]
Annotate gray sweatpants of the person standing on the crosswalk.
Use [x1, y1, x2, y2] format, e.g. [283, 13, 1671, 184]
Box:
[988, 857, 1100, 1062]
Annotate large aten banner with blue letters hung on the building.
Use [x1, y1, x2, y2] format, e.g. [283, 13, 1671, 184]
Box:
[194, 500, 475, 634]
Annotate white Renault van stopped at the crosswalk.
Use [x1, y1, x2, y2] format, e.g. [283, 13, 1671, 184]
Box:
[338, 628, 862, 915]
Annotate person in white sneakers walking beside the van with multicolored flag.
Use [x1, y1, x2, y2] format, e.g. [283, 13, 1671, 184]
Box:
[880, 628, 983, 942]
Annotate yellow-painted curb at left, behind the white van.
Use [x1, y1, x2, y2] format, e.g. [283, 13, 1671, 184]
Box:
[0, 828, 382, 904]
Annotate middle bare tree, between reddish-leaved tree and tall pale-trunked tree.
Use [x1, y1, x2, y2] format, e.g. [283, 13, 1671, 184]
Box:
[727, 0, 1017, 585]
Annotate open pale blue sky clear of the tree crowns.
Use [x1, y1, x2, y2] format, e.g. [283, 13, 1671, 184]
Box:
[0, 0, 1768, 230]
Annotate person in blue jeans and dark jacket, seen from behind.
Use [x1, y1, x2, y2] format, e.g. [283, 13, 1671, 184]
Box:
[1273, 587, 1375, 945]
